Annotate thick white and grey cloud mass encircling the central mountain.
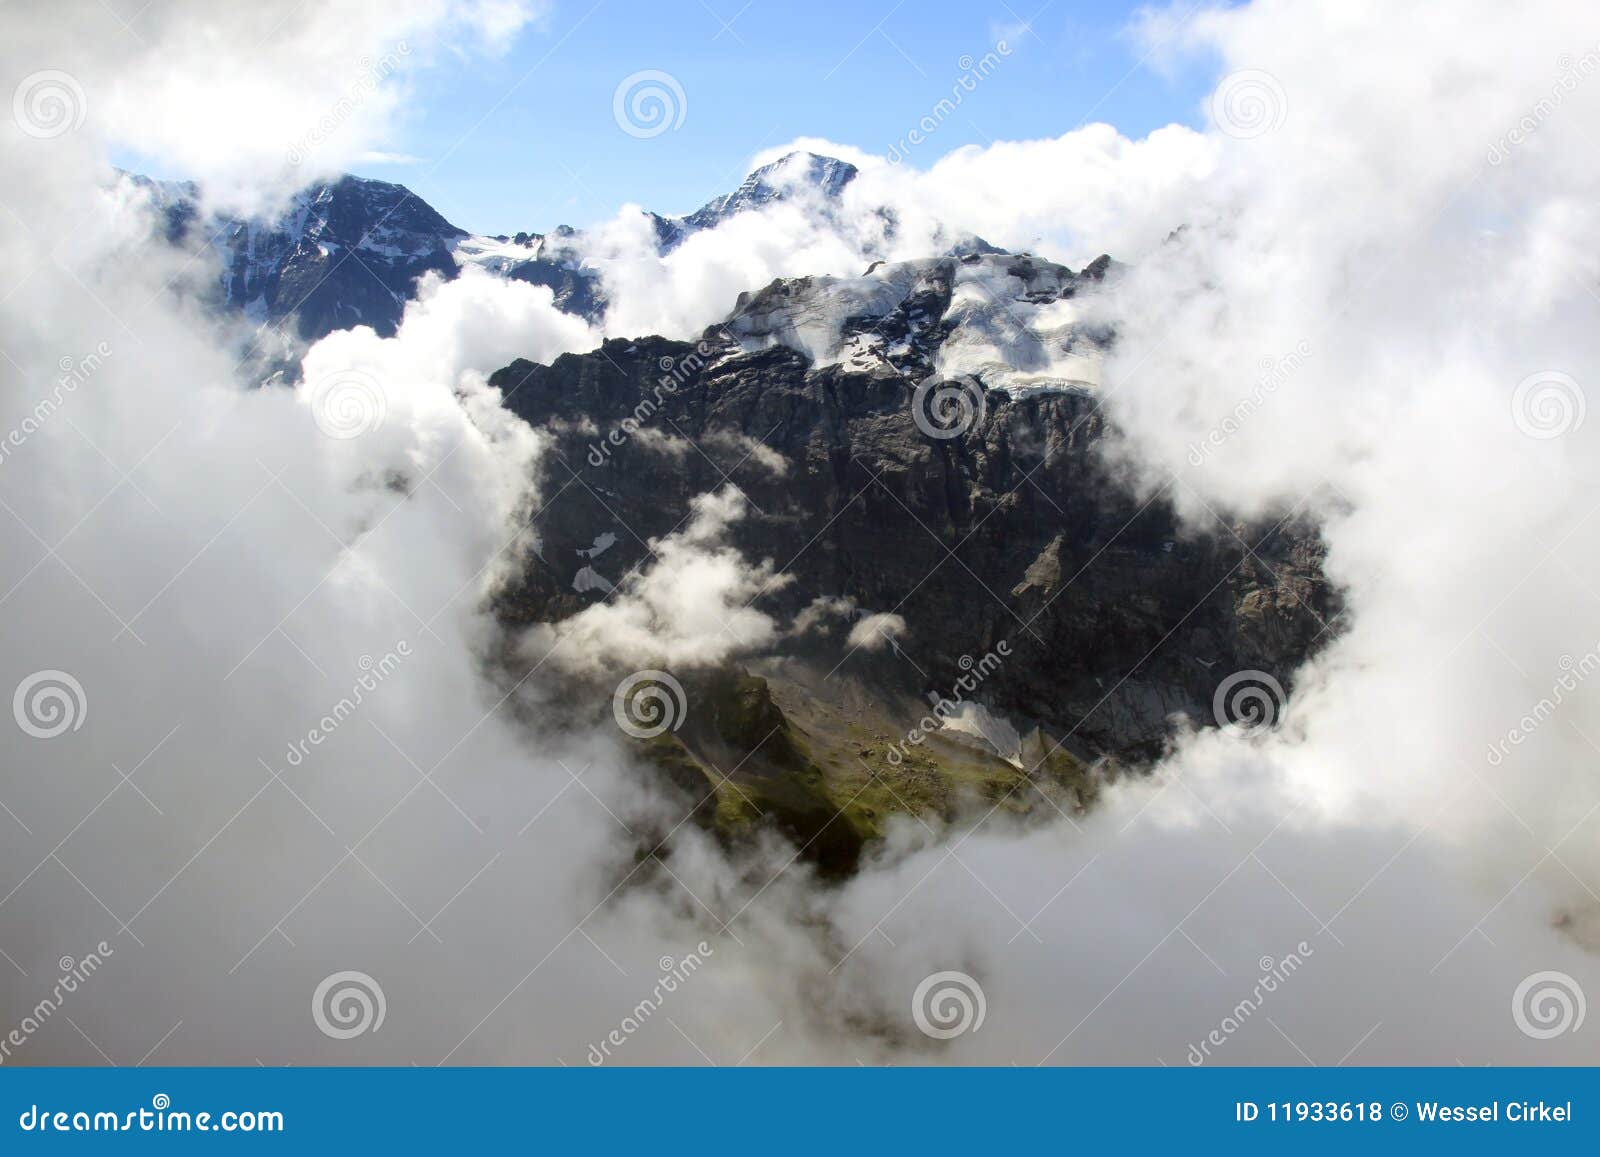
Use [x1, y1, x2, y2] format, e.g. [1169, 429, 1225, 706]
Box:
[0, 0, 1600, 1064]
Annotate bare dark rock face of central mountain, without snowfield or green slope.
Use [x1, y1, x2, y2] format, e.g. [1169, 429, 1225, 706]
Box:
[493, 254, 1338, 870]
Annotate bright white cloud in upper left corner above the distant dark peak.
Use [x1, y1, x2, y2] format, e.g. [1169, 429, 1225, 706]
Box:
[5, 0, 544, 211]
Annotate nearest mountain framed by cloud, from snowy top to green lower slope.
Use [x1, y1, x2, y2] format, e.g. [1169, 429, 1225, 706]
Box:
[491, 253, 1338, 871]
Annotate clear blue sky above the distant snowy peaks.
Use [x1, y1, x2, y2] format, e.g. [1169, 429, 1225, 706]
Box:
[357, 0, 1205, 232]
